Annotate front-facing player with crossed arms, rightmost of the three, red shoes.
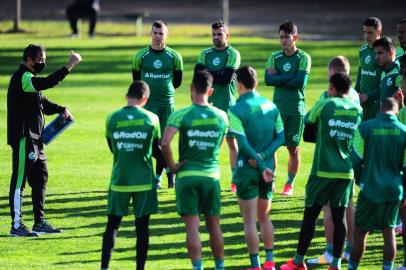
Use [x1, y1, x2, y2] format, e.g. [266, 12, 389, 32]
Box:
[265, 21, 311, 196]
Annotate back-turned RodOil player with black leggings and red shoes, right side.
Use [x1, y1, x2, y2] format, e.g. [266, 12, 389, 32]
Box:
[280, 73, 362, 270]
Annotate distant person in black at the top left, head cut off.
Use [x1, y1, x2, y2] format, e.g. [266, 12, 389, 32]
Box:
[66, 0, 100, 37]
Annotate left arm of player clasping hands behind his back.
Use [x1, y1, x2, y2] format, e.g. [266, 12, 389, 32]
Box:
[228, 108, 267, 172]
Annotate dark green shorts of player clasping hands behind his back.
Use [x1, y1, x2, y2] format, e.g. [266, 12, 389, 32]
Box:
[233, 168, 273, 200]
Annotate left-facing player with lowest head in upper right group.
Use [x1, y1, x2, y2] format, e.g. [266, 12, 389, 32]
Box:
[360, 37, 402, 102]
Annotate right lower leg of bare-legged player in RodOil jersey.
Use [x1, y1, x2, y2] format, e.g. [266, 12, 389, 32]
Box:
[205, 215, 224, 270]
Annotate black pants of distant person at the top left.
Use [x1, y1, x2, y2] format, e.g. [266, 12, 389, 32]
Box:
[66, 4, 97, 34]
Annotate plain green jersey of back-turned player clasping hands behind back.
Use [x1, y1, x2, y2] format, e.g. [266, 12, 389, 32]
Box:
[228, 90, 284, 174]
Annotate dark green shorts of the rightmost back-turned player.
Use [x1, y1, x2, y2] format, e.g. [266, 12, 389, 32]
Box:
[355, 192, 400, 231]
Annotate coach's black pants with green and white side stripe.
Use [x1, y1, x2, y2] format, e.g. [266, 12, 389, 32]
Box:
[9, 137, 48, 228]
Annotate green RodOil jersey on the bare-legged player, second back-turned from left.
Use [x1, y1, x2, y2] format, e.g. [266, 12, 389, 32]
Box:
[167, 104, 228, 179]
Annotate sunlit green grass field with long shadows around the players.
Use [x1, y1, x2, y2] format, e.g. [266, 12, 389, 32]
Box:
[0, 22, 403, 269]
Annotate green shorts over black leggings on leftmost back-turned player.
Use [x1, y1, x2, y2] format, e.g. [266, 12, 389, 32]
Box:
[107, 188, 158, 217]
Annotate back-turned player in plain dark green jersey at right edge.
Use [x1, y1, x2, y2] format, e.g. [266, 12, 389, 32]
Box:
[348, 97, 406, 270]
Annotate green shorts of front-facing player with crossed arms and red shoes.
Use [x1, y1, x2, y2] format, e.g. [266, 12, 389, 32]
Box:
[281, 115, 304, 147]
